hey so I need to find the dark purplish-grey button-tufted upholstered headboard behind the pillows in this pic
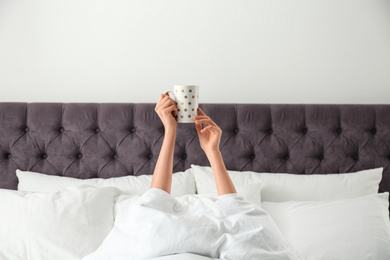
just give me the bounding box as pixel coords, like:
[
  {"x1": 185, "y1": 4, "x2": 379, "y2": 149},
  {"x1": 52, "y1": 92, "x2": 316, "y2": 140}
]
[{"x1": 0, "y1": 103, "x2": 390, "y2": 199}]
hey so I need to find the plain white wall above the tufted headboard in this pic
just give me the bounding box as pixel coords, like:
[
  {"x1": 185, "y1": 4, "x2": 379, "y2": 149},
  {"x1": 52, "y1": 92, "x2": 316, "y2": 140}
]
[{"x1": 0, "y1": 0, "x2": 390, "y2": 104}]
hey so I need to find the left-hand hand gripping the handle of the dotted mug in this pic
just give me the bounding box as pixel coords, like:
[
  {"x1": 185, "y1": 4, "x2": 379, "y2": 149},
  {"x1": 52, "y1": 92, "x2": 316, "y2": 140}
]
[{"x1": 154, "y1": 94, "x2": 178, "y2": 130}]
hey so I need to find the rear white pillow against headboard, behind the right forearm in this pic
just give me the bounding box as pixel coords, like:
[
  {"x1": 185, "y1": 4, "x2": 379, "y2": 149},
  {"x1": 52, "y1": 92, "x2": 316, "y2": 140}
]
[{"x1": 191, "y1": 164, "x2": 383, "y2": 202}]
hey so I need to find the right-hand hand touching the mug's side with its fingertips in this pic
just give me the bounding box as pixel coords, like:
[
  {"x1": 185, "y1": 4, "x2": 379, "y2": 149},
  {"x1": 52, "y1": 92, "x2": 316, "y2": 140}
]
[{"x1": 194, "y1": 108, "x2": 222, "y2": 154}]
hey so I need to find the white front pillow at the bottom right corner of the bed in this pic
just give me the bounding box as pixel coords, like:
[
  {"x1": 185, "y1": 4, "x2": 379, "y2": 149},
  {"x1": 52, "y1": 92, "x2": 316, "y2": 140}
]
[{"x1": 262, "y1": 192, "x2": 390, "y2": 260}]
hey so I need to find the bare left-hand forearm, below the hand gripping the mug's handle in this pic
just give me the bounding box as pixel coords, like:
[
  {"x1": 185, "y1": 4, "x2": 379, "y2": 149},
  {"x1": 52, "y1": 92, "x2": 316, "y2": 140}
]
[{"x1": 150, "y1": 129, "x2": 176, "y2": 193}]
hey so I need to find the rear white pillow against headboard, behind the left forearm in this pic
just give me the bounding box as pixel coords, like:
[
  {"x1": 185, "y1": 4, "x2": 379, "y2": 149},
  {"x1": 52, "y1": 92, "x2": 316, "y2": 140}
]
[{"x1": 16, "y1": 170, "x2": 195, "y2": 196}]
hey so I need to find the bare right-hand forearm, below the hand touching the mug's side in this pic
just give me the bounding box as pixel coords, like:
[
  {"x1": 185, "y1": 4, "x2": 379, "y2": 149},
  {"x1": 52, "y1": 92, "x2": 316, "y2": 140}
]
[{"x1": 206, "y1": 150, "x2": 237, "y2": 195}]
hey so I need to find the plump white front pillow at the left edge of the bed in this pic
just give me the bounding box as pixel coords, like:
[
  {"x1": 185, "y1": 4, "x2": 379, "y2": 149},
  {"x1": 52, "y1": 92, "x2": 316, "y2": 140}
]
[{"x1": 0, "y1": 185, "x2": 118, "y2": 260}]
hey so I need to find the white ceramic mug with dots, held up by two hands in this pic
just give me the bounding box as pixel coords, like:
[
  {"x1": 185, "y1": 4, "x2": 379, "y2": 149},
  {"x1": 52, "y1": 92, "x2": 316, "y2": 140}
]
[{"x1": 164, "y1": 85, "x2": 199, "y2": 123}]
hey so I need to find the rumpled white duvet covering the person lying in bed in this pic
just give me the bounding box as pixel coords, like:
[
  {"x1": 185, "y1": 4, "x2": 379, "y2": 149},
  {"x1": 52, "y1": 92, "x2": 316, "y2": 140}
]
[{"x1": 83, "y1": 189, "x2": 301, "y2": 260}]
